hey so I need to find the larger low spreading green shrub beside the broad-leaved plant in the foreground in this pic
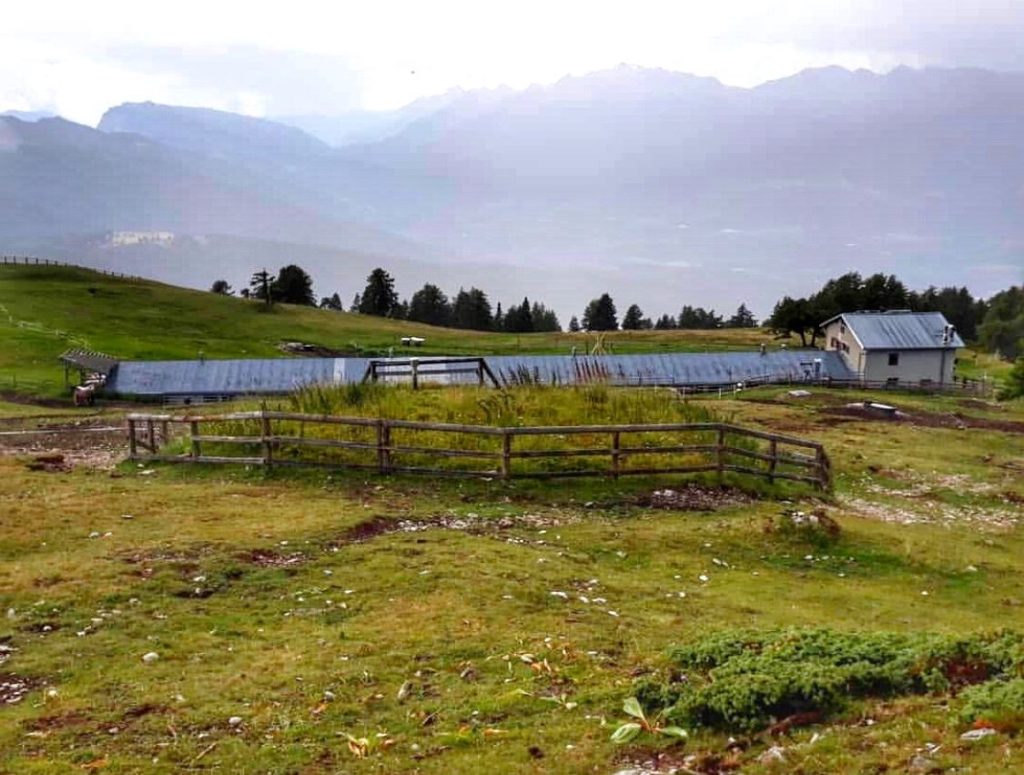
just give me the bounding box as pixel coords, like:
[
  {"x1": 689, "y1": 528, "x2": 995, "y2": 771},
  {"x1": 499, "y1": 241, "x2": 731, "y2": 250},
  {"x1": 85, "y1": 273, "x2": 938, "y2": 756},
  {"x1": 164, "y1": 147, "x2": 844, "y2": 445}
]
[{"x1": 637, "y1": 629, "x2": 1024, "y2": 731}]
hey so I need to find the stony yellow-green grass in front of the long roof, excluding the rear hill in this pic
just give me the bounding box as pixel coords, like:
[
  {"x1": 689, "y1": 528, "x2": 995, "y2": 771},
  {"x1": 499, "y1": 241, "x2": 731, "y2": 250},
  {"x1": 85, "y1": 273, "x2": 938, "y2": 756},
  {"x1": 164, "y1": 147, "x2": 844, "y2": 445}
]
[{"x1": 0, "y1": 388, "x2": 1024, "y2": 773}]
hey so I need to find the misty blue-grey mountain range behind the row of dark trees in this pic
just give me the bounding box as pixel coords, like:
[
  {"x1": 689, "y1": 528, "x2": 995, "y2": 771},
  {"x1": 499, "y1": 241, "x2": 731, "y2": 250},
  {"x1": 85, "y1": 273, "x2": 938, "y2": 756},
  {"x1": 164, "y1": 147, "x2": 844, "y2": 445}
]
[{"x1": 0, "y1": 66, "x2": 1024, "y2": 322}]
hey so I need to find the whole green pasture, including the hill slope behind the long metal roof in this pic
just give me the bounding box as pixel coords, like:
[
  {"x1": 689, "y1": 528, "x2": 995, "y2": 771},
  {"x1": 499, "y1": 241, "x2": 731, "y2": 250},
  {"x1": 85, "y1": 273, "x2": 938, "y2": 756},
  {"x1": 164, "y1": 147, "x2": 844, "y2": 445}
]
[{"x1": 0, "y1": 266, "x2": 1024, "y2": 775}]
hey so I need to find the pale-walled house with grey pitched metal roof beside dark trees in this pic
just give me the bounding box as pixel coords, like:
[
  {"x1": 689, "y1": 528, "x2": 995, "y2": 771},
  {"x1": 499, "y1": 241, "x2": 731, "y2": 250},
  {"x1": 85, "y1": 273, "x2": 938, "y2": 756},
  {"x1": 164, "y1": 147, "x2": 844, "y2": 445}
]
[{"x1": 821, "y1": 310, "x2": 964, "y2": 385}]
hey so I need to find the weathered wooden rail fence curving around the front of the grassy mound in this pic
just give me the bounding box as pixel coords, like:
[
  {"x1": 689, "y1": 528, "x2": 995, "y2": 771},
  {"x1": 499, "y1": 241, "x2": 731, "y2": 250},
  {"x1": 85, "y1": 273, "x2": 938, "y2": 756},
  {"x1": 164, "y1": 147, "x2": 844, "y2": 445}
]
[{"x1": 127, "y1": 411, "x2": 831, "y2": 490}]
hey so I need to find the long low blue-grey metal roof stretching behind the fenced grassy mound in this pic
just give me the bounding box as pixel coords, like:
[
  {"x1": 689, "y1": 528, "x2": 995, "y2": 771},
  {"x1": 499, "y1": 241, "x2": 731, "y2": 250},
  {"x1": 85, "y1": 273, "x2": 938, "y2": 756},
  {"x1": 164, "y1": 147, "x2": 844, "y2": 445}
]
[{"x1": 108, "y1": 350, "x2": 856, "y2": 397}]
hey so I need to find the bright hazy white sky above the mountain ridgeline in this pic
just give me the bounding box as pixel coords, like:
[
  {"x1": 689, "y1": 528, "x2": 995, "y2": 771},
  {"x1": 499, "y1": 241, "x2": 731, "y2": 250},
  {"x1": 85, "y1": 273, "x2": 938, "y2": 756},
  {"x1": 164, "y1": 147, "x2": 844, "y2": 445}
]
[{"x1": 0, "y1": 0, "x2": 1024, "y2": 124}]
